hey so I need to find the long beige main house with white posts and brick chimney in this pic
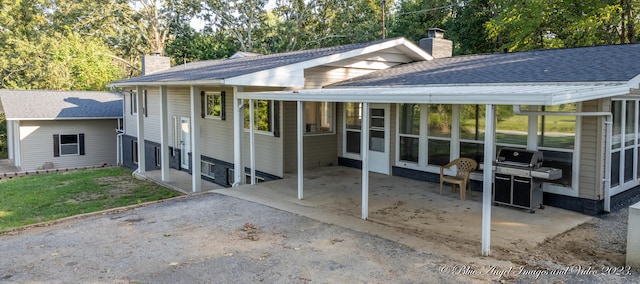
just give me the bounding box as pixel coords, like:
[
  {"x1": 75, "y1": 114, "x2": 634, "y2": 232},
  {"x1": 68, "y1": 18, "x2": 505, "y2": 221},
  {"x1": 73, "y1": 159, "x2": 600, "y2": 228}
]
[{"x1": 111, "y1": 30, "x2": 640, "y2": 254}]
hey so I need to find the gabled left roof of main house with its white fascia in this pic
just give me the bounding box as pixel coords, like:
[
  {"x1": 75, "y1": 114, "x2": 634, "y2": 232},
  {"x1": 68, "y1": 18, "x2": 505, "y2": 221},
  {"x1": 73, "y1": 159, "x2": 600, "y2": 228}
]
[{"x1": 110, "y1": 38, "x2": 431, "y2": 87}]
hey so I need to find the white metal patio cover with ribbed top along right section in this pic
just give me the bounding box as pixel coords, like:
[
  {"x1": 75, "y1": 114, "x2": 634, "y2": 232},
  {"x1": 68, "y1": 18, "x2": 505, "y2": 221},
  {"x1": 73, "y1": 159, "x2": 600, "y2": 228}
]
[{"x1": 238, "y1": 82, "x2": 629, "y2": 105}]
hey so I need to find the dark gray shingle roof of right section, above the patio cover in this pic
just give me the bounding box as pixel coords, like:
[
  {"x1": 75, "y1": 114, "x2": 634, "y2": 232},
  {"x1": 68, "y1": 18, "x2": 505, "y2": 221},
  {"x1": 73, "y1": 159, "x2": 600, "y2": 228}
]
[{"x1": 331, "y1": 44, "x2": 640, "y2": 87}]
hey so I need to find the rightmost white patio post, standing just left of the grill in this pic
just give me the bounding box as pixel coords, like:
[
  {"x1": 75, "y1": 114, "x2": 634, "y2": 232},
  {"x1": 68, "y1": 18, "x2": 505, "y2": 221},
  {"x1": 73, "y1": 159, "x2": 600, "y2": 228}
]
[{"x1": 482, "y1": 105, "x2": 496, "y2": 256}]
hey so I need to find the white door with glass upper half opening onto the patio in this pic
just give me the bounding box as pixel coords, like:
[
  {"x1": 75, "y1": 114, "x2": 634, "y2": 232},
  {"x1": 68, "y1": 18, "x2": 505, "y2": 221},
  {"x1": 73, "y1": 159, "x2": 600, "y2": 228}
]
[{"x1": 369, "y1": 104, "x2": 390, "y2": 175}]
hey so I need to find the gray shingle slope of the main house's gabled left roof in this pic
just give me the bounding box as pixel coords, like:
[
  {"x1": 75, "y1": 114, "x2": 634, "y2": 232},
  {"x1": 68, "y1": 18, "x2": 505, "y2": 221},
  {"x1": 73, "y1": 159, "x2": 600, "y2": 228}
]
[{"x1": 113, "y1": 38, "x2": 397, "y2": 85}]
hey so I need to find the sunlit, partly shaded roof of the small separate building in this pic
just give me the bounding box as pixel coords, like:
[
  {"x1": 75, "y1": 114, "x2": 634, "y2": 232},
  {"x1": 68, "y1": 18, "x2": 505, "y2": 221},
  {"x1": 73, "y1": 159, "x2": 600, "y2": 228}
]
[{"x1": 0, "y1": 90, "x2": 122, "y2": 120}]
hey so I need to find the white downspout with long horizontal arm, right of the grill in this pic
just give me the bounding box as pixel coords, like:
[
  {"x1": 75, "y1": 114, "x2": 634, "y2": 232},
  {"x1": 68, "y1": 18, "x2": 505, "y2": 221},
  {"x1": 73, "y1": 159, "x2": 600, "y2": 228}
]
[{"x1": 513, "y1": 105, "x2": 613, "y2": 212}]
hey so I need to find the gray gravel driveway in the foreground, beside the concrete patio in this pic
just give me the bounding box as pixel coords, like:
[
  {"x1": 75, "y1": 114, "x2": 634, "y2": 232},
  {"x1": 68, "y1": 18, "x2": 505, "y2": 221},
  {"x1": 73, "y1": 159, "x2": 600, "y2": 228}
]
[{"x1": 0, "y1": 193, "x2": 640, "y2": 283}]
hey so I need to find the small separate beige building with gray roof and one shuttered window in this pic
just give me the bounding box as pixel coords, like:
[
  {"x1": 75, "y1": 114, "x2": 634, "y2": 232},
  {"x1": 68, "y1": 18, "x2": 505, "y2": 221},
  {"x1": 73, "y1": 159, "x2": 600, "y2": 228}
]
[{"x1": 0, "y1": 90, "x2": 122, "y2": 171}]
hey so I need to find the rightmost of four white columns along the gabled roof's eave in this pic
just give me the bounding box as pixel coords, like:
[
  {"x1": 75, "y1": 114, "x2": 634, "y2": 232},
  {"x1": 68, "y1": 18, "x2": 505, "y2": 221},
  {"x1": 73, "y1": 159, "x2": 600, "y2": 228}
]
[{"x1": 233, "y1": 87, "x2": 244, "y2": 186}]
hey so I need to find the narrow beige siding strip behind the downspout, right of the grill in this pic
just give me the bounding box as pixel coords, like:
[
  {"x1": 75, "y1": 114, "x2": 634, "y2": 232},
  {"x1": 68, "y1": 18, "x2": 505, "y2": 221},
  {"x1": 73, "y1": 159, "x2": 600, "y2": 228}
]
[{"x1": 576, "y1": 100, "x2": 610, "y2": 200}]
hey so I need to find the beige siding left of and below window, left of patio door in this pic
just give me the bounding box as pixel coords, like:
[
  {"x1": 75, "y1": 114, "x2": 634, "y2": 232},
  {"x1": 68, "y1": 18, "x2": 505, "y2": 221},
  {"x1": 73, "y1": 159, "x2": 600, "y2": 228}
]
[{"x1": 283, "y1": 102, "x2": 338, "y2": 173}]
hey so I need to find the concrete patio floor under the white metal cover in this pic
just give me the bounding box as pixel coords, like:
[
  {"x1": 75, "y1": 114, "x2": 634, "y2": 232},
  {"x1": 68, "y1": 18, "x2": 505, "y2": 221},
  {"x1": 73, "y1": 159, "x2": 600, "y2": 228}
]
[{"x1": 136, "y1": 166, "x2": 592, "y2": 262}]
